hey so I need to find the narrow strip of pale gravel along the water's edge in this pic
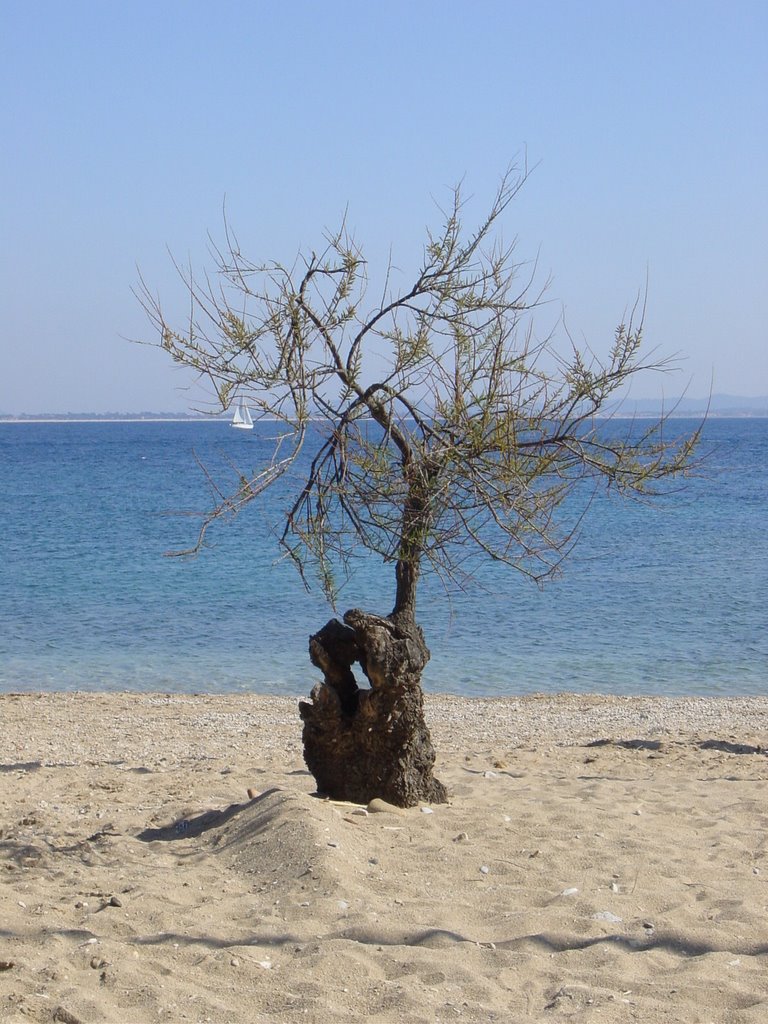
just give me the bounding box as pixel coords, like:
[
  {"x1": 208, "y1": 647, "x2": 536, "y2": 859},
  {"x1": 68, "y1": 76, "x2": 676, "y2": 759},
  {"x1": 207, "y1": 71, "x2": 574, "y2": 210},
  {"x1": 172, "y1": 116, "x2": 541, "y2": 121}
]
[{"x1": 0, "y1": 692, "x2": 768, "y2": 769}]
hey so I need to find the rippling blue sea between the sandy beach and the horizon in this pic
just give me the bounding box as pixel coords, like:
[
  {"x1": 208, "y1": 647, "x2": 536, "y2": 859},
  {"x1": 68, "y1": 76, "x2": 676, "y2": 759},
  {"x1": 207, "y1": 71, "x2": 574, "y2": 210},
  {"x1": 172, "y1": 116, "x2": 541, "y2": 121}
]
[{"x1": 0, "y1": 418, "x2": 768, "y2": 697}]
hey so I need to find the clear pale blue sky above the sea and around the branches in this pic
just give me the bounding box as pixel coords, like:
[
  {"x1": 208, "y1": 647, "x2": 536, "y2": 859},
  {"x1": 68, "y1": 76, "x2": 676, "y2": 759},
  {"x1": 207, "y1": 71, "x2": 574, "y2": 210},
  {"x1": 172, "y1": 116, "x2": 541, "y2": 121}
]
[{"x1": 0, "y1": 0, "x2": 768, "y2": 413}]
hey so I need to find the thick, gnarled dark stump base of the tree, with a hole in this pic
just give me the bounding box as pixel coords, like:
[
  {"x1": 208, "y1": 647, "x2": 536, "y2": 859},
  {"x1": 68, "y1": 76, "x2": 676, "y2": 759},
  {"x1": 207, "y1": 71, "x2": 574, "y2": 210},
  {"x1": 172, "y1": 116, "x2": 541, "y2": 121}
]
[{"x1": 299, "y1": 609, "x2": 446, "y2": 807}]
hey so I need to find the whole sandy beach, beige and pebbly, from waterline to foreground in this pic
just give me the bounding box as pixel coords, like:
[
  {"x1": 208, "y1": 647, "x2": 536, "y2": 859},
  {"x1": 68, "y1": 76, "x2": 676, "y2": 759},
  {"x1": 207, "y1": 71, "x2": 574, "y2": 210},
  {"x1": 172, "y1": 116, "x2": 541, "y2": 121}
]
[{"x1": 0, "y1": 694, "x2": 768, "y2": 1024}]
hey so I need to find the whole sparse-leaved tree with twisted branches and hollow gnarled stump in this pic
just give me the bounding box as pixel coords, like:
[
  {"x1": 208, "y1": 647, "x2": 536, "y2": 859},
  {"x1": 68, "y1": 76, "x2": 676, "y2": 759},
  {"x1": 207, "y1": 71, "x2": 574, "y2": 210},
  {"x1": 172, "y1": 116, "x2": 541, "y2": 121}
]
[{"x1": 140, "y1": 170, "x2": 698, "y2": 806}]
